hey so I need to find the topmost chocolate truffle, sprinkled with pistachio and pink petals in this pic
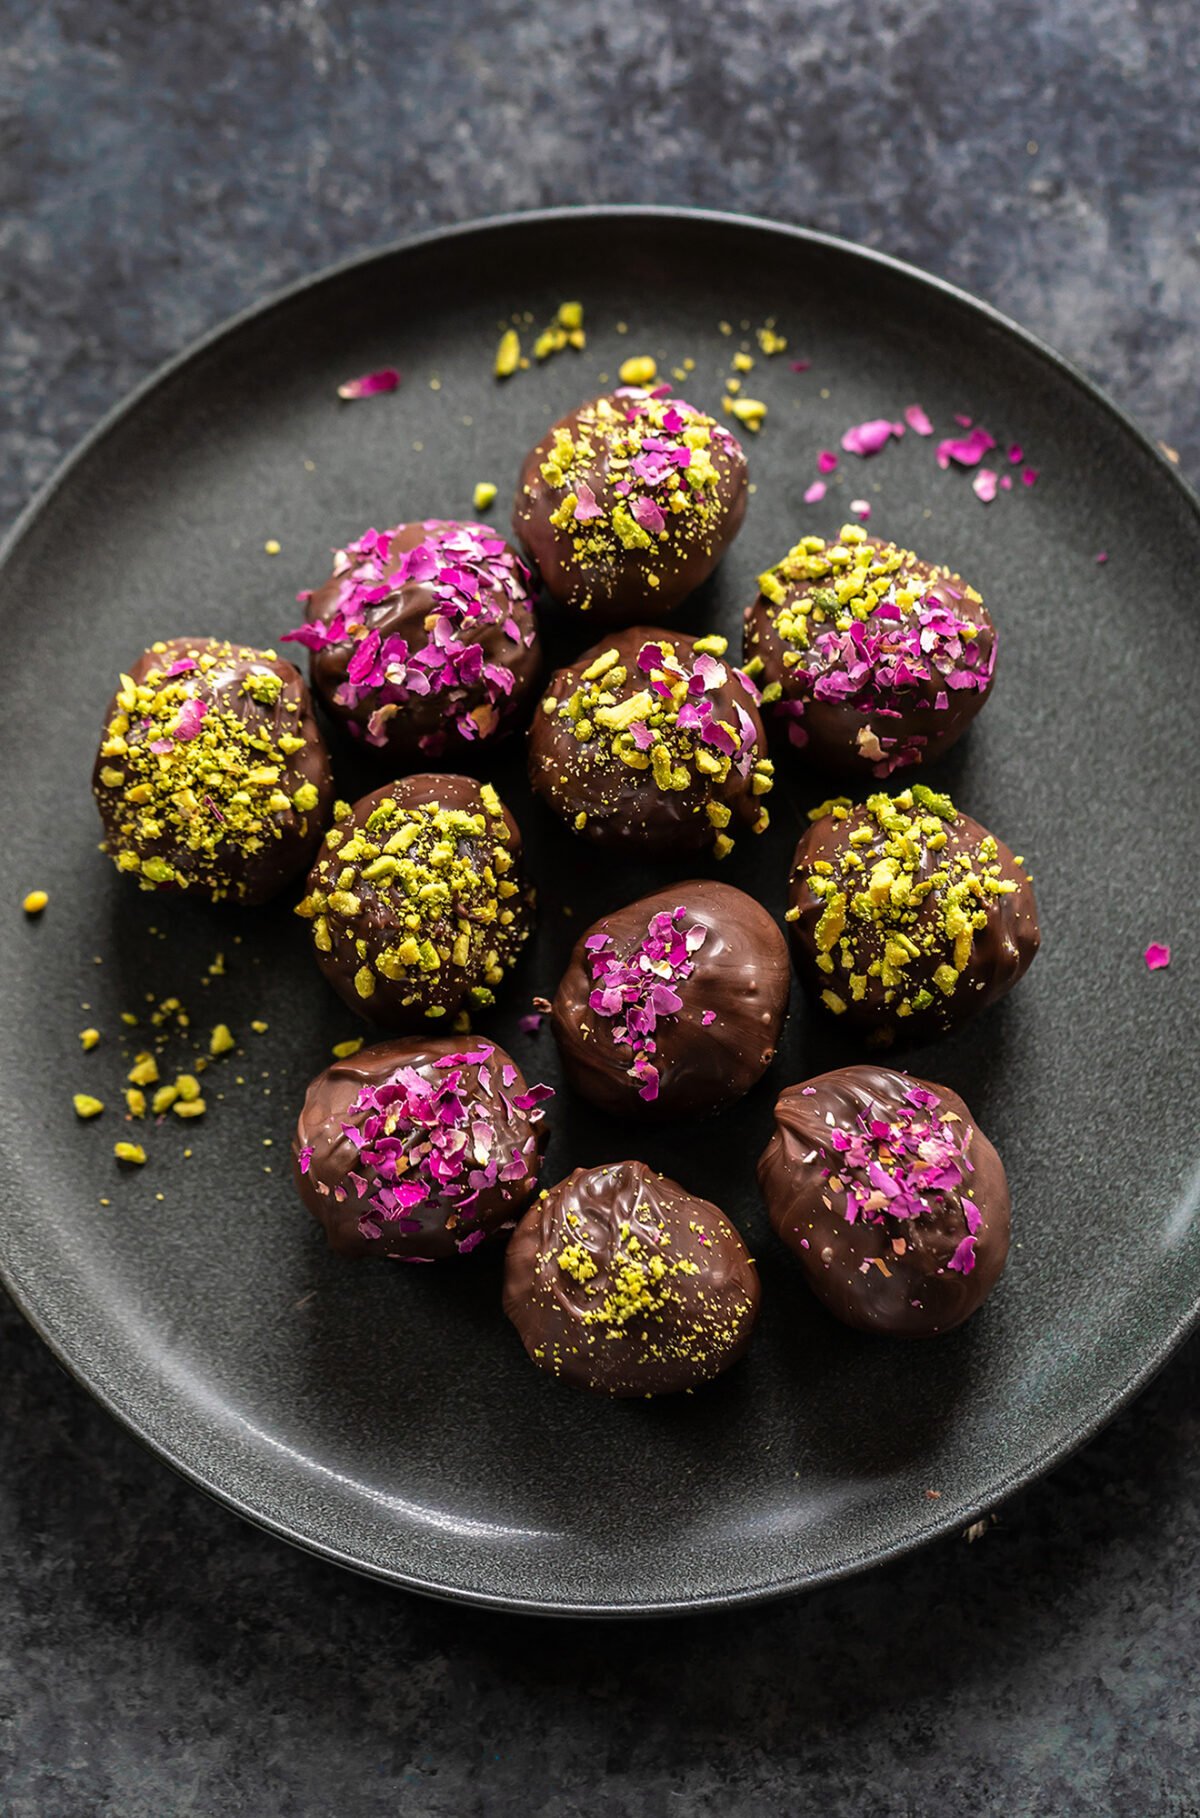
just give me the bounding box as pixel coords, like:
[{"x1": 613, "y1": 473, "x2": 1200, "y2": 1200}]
[{"x1": 513, "y1": 385, "x2": 747, "y2": 625}]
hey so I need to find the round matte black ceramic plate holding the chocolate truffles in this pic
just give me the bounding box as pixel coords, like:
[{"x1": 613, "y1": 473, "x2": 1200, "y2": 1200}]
[{"x1": 0, "y1": 211, "x2": 1200, "y2": 1613}]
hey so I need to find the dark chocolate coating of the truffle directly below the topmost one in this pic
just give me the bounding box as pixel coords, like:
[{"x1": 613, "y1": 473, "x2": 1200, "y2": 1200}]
[{"x1": 529, "y1": 625, "x2": 771, "y2": 858}]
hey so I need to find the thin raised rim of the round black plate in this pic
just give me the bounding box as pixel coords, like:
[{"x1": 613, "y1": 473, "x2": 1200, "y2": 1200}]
[{"x1": 0, "y1": 202, "x2": 1200, "y2": 1620}]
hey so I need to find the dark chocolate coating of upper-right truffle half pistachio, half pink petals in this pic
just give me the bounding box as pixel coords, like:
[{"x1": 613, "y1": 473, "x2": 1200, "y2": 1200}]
[{"x1": 745, "y1": 527, "x2": 996, "y2": 776}]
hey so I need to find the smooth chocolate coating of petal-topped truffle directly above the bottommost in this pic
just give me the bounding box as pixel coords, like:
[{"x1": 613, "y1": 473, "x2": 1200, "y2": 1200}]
[{"x1": 551, "y1": 878, "x2": 791, "y2": 1122}]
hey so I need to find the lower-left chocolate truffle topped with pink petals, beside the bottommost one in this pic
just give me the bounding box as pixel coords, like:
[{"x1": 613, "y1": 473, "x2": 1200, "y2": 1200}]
[{"x1": 291, "y1": 1036, "x2": 553, "y2": 1262}]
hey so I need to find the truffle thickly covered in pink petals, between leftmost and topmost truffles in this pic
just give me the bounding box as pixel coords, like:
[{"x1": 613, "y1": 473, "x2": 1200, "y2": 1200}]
[{"x1": 285, "y1": 518, "x2": 538, "y2": 765}]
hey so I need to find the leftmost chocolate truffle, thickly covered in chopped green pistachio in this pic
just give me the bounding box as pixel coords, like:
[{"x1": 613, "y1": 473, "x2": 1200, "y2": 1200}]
[{"x1": 91, "y1": 638, "x2": 333, "y2": 904}]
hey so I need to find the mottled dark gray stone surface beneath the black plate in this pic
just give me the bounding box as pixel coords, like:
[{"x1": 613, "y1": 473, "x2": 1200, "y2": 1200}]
[{"x1": 0, "y1": 0, "x2": 1200, "y2": 1818}]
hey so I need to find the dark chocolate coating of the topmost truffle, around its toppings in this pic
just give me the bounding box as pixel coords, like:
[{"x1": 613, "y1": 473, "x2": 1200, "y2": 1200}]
[{"x1": 513, "y1": 387, "x2": 747, "y2": 625}]
